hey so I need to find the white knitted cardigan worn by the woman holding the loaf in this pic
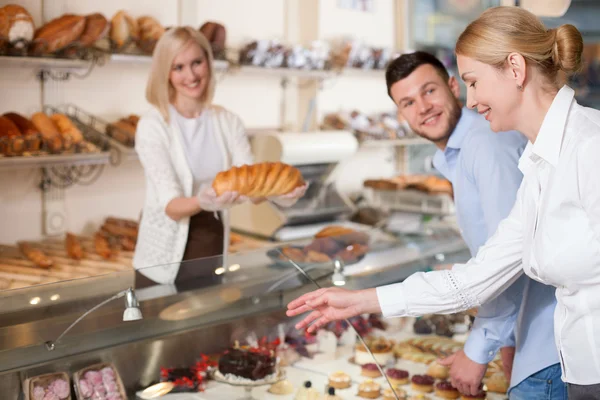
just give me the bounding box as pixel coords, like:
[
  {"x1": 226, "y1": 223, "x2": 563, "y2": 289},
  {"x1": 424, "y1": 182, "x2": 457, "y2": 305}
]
[{"x1": 133, "y1": 105, "x2": 252, "y2": 284}]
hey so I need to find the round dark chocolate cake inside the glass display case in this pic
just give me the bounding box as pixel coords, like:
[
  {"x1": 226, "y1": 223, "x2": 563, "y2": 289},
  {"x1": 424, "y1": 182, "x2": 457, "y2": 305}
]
[{"x1": 219, "y1": 348, "x2": 276, "y2": 381}]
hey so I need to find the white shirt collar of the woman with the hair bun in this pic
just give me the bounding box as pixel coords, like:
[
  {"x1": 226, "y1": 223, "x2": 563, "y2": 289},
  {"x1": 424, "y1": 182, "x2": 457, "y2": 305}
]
[{"x1": 523, "y1": 85, "x2": 575, "y2": 167}]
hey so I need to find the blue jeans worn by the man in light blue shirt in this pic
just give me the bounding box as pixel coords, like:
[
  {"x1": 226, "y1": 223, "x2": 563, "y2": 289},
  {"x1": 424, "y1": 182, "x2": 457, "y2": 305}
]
[{"x1": 508, "y1": 364, "x2": 567, "y2": 400}]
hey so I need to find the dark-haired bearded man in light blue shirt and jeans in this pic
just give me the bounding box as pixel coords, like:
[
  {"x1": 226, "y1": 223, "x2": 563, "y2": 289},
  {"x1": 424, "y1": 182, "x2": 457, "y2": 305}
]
[{"x1": 386, "y1": 52, "x2": 567, "y2": 400}]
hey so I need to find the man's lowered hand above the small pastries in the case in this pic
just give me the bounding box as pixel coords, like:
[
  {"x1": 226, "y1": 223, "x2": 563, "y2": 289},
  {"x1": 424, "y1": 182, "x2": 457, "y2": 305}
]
[{"x1": 438, "y1": 350, "x2": 487, "y2": 396}]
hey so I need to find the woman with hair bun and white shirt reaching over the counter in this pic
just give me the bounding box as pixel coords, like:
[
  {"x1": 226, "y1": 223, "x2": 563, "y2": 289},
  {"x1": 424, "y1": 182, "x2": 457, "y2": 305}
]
[{"x1": 288, "y1": 7, "x2": 600, "y2": 400}]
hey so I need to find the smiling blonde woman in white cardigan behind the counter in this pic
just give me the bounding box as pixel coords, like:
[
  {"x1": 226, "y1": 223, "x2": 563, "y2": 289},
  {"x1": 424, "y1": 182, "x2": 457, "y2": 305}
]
[{"x1": 133, "y1": 27, "x2": 306, "y2": 288}]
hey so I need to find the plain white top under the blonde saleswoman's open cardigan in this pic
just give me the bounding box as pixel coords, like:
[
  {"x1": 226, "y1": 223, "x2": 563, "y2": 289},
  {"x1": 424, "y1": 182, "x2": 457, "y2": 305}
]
[{"x1": 170, "y1": 106, "x2": 223, "y2": 193}]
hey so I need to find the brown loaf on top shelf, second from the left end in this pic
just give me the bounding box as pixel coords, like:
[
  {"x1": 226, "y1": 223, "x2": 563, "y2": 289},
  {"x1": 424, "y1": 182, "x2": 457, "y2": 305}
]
[{"x1": 33, "y1": 14, "x2": 85, "y2": 53}]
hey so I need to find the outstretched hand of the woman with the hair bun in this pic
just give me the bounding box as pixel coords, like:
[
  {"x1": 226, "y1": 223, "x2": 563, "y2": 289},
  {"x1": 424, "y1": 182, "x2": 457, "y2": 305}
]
[{"x1": 287, "y1": 288, "x2": 381, "y2": 332}]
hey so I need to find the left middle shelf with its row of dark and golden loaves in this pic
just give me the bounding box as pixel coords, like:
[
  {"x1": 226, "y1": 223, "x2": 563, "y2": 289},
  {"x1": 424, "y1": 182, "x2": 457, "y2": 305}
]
[{"x1": 0, "y1": 106, "x2": 110, "y2": 170}]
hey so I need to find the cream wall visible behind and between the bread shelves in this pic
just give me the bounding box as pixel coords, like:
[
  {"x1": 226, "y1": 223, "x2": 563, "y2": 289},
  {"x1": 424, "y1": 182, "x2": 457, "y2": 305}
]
[{"x1": 0, "y1": 0, "x2": 420, "y2": 243}]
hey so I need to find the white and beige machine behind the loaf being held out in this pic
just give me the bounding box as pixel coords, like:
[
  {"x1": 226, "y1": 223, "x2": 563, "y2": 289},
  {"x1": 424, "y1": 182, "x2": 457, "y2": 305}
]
[{"x1": 231, "y1": 131, "x2": 358, "y2": 241}]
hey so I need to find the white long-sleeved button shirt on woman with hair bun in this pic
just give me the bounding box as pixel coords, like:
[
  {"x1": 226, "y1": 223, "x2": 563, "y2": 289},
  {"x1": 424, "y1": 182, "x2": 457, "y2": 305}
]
[{"x1": 377, "y1": 86, "x2": 600, "y2": 385}]
